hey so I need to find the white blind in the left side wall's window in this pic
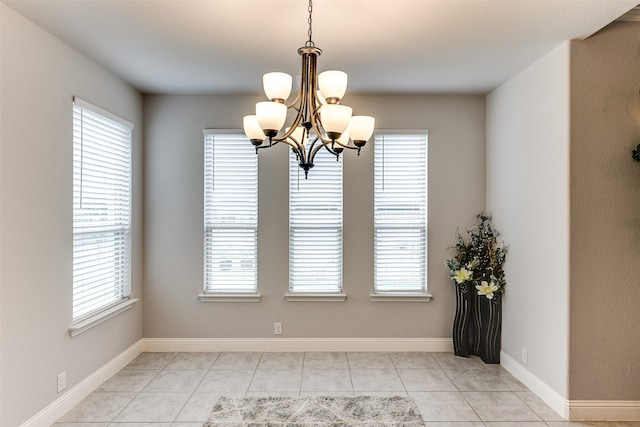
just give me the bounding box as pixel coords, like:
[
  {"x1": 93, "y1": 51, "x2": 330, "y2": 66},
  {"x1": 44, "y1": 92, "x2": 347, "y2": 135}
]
[{"x1": 73, "y1": 98, "x2": 133, "y2": 322}]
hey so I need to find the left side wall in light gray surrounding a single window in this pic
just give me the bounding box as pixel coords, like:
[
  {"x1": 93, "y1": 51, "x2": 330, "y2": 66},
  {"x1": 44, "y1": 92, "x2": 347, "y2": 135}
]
[{"x1": 0, "y1": 4, "x2": 142, "y2": 426}]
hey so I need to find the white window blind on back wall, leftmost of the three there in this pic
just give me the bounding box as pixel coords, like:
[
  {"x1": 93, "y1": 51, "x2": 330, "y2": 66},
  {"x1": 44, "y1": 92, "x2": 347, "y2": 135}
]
[{"x1": 204, "y1": 130, "x2": 258, "y2": 293}]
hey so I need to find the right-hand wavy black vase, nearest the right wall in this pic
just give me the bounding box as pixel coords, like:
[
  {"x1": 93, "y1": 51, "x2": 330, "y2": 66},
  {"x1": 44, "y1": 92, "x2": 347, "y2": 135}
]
[{"x1": 472, "y1": 294, "x2": 502, "y2": 363}]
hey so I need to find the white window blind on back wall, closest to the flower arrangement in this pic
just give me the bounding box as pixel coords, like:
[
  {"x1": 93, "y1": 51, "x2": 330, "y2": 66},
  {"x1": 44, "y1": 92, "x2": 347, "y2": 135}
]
[{"x1": 374, "y1": 134, "x2": 427, "y2": 293}]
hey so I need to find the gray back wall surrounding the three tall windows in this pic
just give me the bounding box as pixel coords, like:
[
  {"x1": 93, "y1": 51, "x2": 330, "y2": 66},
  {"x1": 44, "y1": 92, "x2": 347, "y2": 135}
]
[{"x1": 144, "y1": 94, "x2": 485, "y2": 338}]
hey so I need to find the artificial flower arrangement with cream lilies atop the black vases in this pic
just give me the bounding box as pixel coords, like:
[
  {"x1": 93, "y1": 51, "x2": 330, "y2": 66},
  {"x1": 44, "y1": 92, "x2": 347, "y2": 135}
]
[{"x1": 445, "y1": 213, "x2": 507, "y2": 299}]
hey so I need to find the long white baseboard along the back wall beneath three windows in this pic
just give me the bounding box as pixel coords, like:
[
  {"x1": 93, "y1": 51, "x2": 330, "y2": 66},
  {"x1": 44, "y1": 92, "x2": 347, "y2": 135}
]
[{"x1": 142, "y1": 338, "x2": 453, "y2": 352}]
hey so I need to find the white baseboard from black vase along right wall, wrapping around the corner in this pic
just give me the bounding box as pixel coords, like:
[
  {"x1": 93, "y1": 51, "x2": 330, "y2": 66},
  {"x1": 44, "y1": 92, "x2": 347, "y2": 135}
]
[{"x1": 500, "y1": 352, "x2": 640, "y2": 421}]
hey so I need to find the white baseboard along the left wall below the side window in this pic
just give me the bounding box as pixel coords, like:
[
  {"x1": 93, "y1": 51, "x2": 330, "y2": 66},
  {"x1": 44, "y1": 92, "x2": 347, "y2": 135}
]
[{"x1": 20, "y1": 340, "x2": 142, "y2": 427}]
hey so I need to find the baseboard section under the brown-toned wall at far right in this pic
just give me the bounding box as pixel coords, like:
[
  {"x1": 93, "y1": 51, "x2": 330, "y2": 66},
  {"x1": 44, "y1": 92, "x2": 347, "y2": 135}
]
[{"x1": 569, "y1": 400, "x2": 640, "y2": 421}]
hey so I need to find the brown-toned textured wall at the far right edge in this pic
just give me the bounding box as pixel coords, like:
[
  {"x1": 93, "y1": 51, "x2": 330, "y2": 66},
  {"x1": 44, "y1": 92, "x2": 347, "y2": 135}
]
[{"x1": 569, "y1": 22, "x2": 640, "y2": 401}]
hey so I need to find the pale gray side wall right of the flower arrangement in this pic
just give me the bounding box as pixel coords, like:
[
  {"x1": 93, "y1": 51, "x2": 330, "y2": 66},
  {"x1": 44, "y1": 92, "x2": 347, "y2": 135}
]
[{"x1": 487, "y1": 43, "x2": 569, "y2": 398}]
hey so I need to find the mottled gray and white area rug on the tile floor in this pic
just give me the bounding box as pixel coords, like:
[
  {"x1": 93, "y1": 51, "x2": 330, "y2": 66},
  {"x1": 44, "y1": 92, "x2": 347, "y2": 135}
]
[{"x1": 204, "y1": 396, "x2": 424, "y2": 427}]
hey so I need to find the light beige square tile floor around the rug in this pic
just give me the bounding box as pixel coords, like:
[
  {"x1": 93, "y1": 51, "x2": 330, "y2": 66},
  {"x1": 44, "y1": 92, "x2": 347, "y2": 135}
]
[{"x1": 54, "y1": 352, "x2": 640, "y2": 427}]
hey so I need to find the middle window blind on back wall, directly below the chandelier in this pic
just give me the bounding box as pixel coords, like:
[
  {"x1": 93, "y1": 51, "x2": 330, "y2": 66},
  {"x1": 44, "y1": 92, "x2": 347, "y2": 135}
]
[{"x1": 289, "y1": 149, "x2": 342, "y2": 293}]
